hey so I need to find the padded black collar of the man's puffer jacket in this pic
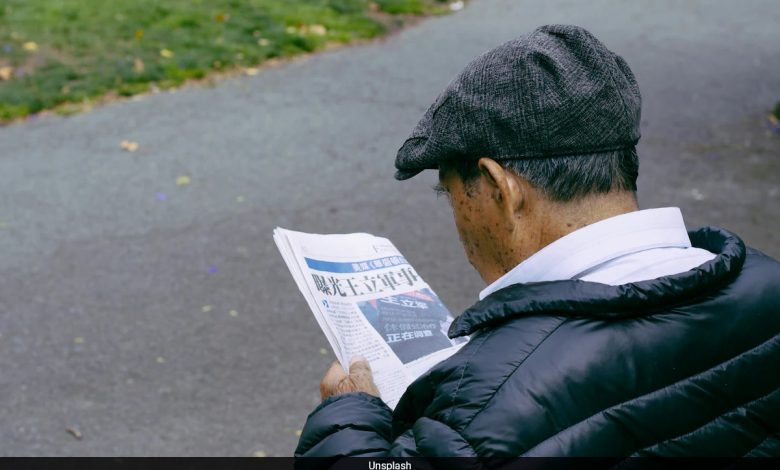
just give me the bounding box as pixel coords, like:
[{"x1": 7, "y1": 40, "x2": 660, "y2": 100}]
[{"x1": 449, "y1": 227, "x2": 745, "y2": 338}]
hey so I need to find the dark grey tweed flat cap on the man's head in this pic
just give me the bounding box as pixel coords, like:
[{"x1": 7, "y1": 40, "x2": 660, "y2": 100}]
[{"x1": 395, "y1": 25, "x2": 641, "y2": 180}]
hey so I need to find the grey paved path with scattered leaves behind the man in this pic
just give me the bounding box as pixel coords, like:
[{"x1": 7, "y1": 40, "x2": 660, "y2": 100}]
[{"x1": 0, "y1": 0, "x2": 780, "y2": 455}]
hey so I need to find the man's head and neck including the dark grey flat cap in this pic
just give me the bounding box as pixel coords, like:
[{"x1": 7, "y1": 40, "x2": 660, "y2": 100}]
[{"x1": 396, "y1": 25, "x2": 641, "y2": 282}]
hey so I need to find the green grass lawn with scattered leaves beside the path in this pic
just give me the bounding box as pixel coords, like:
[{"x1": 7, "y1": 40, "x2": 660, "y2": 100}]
[{"x1": 0, "y1": 0, "x2": 448, "y2": 123}]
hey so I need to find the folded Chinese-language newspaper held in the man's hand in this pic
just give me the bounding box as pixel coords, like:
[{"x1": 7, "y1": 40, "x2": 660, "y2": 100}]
[{"x1": 274, "y1": 227, "x2": 468, "y2": 408}]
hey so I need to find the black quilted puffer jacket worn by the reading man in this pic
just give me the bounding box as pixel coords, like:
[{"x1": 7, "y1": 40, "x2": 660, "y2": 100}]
[{"x1": 296, "y1": 228, "x2": 780, "y2": 457}]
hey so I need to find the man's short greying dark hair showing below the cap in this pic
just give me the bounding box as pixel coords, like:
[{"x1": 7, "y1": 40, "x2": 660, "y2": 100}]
[{"x1": 448, "y1": 147, "x2": 639, "y2": 202}]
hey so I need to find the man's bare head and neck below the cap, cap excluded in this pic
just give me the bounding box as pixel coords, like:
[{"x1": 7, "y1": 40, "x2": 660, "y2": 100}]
[{"x1": 435, "y1": 149, "x2": 639, "y2": 283}]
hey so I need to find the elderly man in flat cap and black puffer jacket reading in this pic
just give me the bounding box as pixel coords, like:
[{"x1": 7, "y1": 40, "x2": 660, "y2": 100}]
[{"x1": 296, "y1": 26, "x2": 780, "y2": 457}]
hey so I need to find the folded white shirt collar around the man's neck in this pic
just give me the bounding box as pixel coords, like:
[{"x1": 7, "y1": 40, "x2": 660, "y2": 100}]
[{"x1": 479, "y1": 207, "x2": 691, "y2": 300}]
